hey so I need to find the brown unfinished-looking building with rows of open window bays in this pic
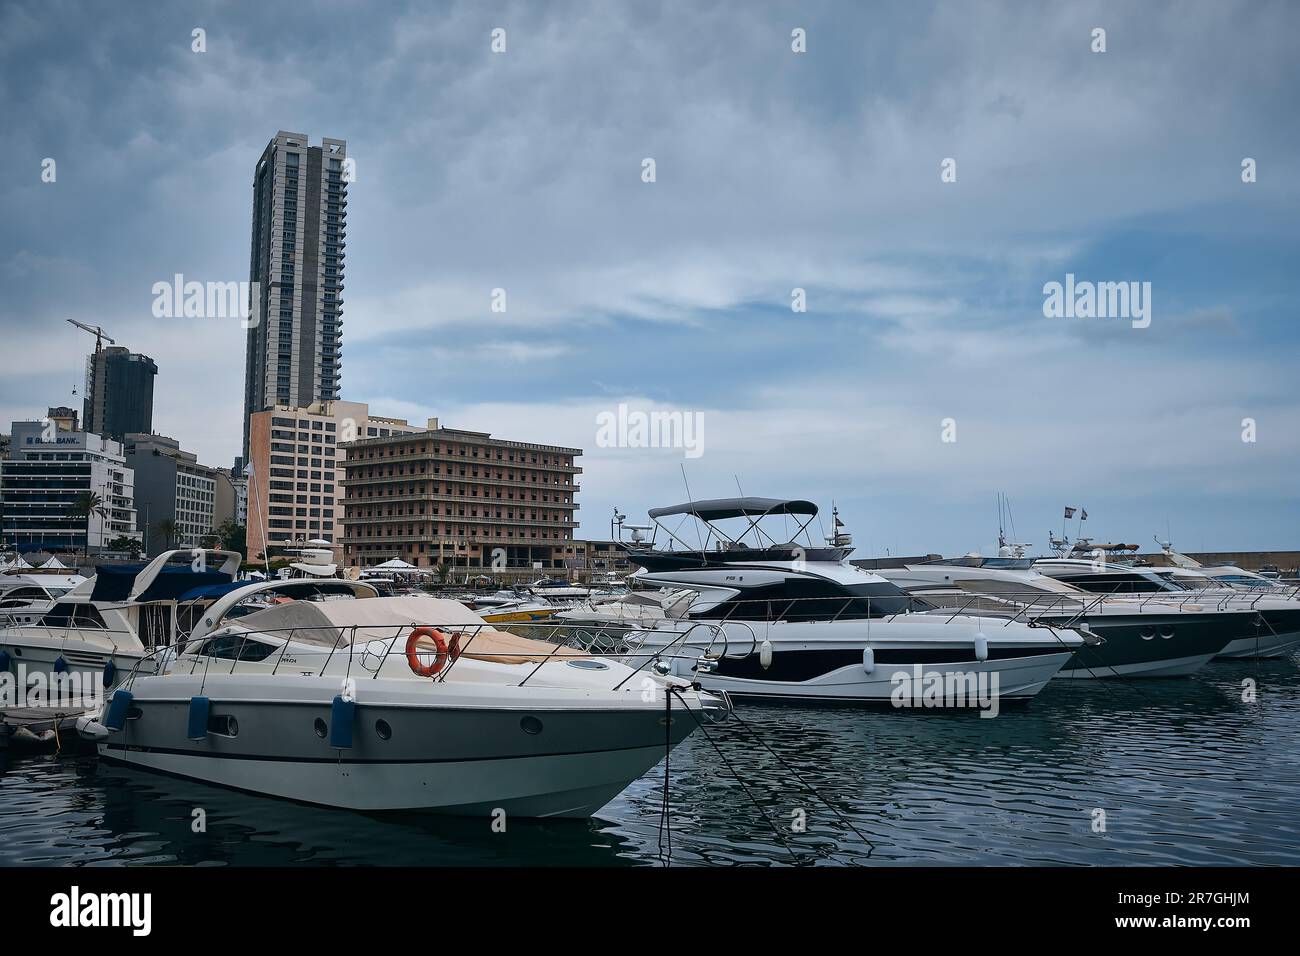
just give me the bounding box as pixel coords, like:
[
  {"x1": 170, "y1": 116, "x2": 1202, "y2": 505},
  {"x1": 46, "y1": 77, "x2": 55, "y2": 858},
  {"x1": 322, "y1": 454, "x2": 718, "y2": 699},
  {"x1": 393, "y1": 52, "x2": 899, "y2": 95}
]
[{"x1": 339, "y1": 419, "x2": 582, "y2": 571}]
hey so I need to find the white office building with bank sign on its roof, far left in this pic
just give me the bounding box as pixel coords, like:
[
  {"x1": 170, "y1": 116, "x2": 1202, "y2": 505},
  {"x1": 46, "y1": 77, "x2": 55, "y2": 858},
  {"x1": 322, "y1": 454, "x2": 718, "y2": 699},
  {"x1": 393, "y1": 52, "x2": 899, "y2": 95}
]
[{"x1": 0, "y1": 408, "x2": 140, "y2": 551}]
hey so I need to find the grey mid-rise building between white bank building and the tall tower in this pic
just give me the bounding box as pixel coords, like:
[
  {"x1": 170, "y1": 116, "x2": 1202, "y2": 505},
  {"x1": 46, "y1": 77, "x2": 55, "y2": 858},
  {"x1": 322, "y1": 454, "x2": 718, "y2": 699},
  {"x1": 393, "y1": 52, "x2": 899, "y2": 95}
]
[{"x1": 125, "y1": 434, "x2": 220, "y2": 554}]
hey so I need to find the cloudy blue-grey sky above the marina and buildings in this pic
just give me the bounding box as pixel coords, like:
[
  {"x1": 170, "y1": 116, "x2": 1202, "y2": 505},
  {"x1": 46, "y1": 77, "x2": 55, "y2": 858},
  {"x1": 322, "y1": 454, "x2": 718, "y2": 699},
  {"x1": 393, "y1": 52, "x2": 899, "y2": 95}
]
[{"x1": 0, "y1": 0, "x2": 1300, "y2": 555}]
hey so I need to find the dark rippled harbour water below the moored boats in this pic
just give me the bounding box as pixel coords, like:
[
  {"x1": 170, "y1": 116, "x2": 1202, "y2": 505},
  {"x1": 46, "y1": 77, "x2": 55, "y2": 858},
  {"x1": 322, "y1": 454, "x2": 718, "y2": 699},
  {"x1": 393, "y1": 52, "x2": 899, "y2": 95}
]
[{"x1": 0, "y1": 658, "x2": 1300, "y2": 866}]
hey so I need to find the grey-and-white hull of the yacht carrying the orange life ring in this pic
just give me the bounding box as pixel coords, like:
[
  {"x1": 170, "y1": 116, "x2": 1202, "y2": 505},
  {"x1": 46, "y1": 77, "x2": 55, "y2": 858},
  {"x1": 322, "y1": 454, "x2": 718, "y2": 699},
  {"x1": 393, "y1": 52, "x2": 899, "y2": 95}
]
[{"x1": 99, "y1": 674, "x2": 699, "y2": 818}]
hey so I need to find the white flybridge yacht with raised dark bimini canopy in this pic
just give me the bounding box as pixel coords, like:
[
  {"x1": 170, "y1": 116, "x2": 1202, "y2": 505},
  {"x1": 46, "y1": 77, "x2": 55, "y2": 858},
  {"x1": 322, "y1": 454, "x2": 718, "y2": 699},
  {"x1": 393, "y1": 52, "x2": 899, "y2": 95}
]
[{"x1": 608, "y1": 497, "x2": 1084, "y2": 706}]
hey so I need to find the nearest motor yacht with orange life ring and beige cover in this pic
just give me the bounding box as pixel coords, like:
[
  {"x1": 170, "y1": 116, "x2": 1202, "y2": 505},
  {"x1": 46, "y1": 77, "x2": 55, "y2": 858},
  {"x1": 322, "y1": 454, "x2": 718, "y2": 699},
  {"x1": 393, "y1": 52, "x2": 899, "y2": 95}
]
[{"x1": 96, "y1": 584, "x2": 729, "y2": 817}]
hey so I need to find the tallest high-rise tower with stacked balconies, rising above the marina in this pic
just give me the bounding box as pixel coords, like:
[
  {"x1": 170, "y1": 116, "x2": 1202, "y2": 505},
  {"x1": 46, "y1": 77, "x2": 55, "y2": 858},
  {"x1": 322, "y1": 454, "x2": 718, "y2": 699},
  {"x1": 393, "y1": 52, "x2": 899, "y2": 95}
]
[{"x1": 244, "y1": 130, "x2": 351, "y2": 460}]
